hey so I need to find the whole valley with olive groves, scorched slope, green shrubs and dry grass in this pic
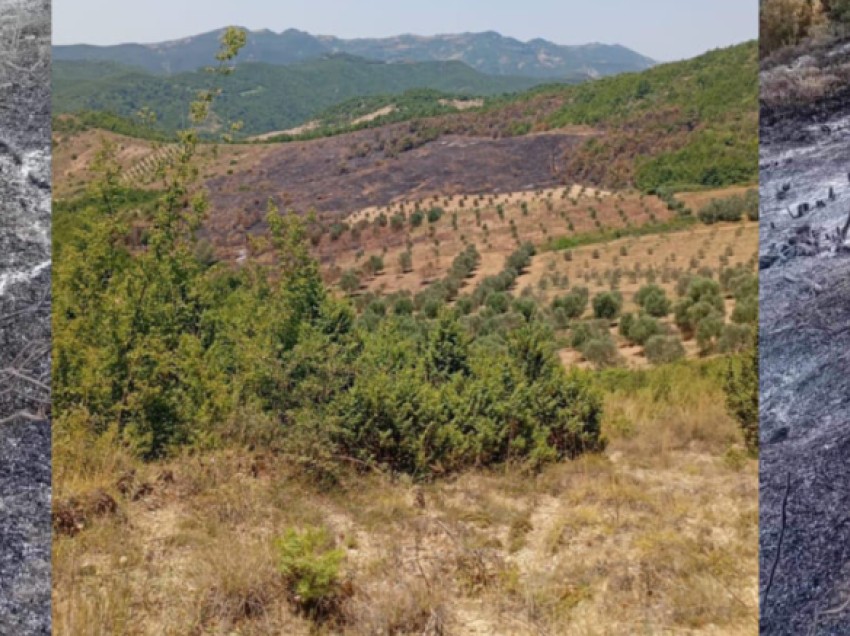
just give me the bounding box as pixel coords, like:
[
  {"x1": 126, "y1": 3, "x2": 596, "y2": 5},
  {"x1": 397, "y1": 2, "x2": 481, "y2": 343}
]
[{"x1": 52, "y1": 26, "x2": 759, "y2": 636}]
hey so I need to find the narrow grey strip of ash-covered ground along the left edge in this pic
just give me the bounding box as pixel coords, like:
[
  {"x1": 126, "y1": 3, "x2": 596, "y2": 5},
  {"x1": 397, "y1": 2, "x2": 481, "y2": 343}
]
[{"x1": 0, "y1": 0, "x2": 50, "y2": 636}]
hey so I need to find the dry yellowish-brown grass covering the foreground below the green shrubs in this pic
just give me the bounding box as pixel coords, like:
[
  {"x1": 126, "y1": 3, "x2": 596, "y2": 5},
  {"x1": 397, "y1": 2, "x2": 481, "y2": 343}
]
[{"x1": 53, "y1": 367, "x2": 758, "y2": 636}]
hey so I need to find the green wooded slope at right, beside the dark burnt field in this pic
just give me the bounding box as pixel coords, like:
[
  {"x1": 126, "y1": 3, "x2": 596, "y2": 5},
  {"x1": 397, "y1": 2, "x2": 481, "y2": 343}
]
[{"x1": 549, "y1": 42, "x2": 759, "y2": 191}]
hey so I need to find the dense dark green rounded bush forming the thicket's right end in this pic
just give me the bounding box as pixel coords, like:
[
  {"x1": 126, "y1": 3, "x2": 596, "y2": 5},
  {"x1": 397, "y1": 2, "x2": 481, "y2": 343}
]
[{"x1": 329, "y1": 320, "x2": 603, "y2": 474}]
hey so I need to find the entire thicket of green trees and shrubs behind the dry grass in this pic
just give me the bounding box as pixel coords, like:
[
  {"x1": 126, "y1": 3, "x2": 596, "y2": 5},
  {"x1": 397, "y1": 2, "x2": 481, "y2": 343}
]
[{"x1": 53, "y1": 36, "x2": 604, "y2": 474}]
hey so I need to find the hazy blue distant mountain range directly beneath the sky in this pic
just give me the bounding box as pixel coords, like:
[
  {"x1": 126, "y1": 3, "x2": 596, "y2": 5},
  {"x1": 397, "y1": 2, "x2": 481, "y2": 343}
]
[{"x1": 53, "y1": 29, "x2": 654, "y2": 79}]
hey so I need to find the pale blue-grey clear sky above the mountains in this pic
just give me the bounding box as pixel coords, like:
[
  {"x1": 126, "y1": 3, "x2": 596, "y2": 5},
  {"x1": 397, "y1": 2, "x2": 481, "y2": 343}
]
[{"x1": 53, "y1": 0, "x2": 758, "y2": 61}]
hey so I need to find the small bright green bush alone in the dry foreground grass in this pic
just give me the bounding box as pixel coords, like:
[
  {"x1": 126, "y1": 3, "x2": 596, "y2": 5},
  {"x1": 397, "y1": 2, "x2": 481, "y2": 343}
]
[{"x1": 276, "y1": 528, "x2": 345, "y2": 610}]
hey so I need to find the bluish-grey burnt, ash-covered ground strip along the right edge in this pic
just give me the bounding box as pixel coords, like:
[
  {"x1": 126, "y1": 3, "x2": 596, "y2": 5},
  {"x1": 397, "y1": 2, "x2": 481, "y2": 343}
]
[{"x1": 760, "y1": 36, "x2": 850, "y2": 636}]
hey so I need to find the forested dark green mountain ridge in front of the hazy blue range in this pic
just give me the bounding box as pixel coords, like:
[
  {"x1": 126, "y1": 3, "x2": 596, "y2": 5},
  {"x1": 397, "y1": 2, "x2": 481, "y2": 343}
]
[{"x1": 53, "y1": 54, "x2": 542, "y2": 135}]
